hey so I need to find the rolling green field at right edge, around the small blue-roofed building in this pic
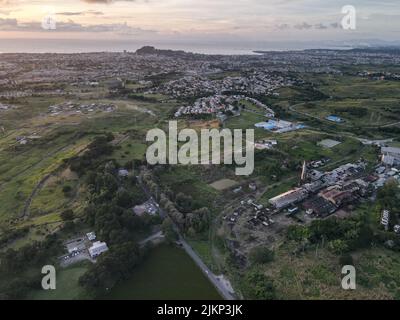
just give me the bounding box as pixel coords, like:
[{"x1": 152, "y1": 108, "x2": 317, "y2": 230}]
[{"x1": 290, "y1": 75, "x2": 400, "y2": 130}]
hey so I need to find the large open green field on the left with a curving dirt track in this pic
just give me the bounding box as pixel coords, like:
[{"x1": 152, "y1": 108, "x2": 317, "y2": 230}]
[{"x1": 0, "y1": 92, "x2": 175, "y2": 238}]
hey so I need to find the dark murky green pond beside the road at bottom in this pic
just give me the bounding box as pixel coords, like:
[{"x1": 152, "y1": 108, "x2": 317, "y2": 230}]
[{"x1": 105, "y1": 245, "x2": 221, "y2": 300}]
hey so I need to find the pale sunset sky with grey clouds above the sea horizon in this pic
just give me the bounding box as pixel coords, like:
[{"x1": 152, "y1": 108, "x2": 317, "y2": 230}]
[{"x1": 0, "y1": 0, "x2": 400, "y2": 49}]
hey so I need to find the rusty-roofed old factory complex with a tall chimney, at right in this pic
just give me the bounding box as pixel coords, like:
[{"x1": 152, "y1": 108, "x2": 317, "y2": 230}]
[{"x1": 269, "y1": 147, "x2": 400, "y2": 217}]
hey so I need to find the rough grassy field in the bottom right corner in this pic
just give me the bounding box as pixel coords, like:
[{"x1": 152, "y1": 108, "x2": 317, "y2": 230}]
[{"x1": 265, "y1": 242, "x2": 400, "y2": 299}]
